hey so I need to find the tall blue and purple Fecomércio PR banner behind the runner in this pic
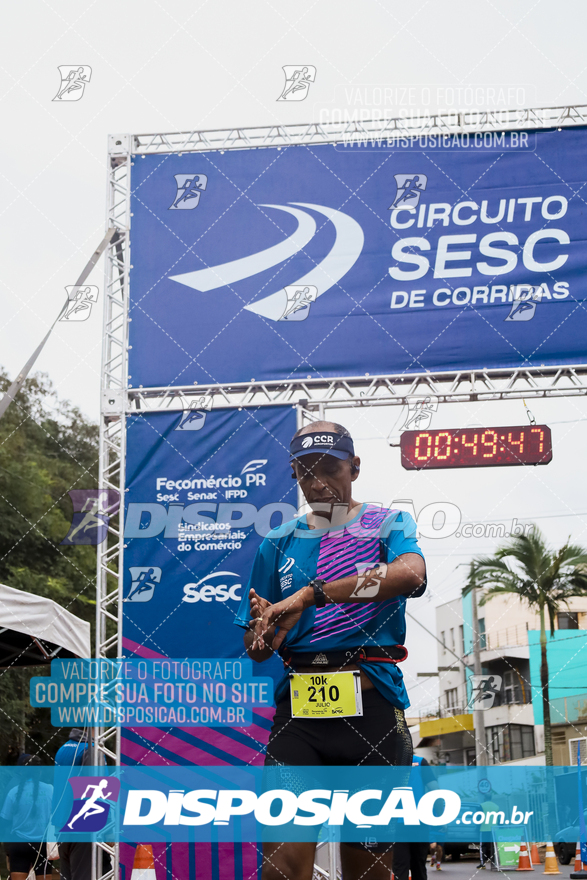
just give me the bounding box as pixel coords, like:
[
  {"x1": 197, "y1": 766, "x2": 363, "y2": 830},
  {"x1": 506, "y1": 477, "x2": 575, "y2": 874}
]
[{"x1": 121, "y1": 407, "x2": 297, "y2": 878}]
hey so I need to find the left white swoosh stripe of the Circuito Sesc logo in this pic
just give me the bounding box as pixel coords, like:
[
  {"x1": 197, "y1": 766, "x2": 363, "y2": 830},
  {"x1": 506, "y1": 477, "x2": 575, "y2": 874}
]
[{"x1": 170, "y1": 205, "x2": 316, "y2": 290}]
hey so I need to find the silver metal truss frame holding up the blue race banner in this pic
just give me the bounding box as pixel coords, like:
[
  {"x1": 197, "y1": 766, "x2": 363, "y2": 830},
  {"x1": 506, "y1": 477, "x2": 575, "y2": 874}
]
[{"x1": 99, "y1": 106, "x2": 587, "y2": 880}]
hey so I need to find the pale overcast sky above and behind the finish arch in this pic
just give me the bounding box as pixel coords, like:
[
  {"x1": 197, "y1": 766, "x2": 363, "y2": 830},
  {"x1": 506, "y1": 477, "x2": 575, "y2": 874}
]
[{"x1": 0, "y1": 0, "x2": 587, "y2": 706}]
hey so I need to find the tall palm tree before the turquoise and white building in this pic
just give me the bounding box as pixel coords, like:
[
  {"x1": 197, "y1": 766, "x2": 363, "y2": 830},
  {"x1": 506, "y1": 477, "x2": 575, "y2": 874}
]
[{"x1": 463, "y1": 528, "x2": 587, "y2": 767}]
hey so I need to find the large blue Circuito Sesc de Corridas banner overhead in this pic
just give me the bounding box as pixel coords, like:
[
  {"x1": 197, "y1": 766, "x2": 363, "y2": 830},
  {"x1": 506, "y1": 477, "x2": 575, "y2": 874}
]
[{"x1": 129, "y1": 128, "x2": 587, "y2": 388}]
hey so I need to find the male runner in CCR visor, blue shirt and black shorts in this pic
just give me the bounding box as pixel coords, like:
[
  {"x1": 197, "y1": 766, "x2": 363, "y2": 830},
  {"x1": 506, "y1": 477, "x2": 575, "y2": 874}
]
[{"x1": 236, "y1": 421, "x2": 426, "y2": 880}]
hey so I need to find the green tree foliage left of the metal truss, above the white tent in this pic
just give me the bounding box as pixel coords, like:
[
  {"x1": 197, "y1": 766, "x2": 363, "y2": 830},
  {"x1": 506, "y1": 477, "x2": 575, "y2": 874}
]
[{"x1": 0, "y1": 373, "x2": 98, "y2": 763}]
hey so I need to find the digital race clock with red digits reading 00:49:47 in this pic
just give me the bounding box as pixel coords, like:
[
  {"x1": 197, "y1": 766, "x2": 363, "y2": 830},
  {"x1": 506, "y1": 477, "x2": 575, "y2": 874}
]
[{"x1": 400, "y1": 425, "x2": 552, "y2": 471}]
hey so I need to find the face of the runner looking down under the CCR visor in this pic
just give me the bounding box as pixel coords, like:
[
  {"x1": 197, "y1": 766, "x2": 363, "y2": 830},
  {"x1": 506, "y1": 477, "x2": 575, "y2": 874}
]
[{"x1": 292, "y1": 453, "x2": 359, "y2": 504}]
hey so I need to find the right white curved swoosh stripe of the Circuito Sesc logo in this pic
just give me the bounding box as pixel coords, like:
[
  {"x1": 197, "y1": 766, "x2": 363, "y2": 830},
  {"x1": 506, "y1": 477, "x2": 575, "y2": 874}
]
[{"x1": 245, "y1": 202, "x2": 365, "y2": 321}]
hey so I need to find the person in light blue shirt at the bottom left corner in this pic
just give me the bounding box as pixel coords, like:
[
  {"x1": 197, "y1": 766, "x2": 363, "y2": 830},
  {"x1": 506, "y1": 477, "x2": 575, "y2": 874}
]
[{"x1": 0, "y1": 754, "x2": 53, "y2": 880}]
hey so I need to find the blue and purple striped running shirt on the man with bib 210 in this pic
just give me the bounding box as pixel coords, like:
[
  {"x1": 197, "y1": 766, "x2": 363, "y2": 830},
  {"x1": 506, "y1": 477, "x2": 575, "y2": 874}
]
[{"x1": 235, "y1": 504, "x2": 426, "y2": 709}]
